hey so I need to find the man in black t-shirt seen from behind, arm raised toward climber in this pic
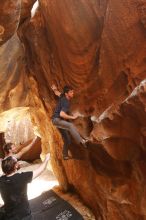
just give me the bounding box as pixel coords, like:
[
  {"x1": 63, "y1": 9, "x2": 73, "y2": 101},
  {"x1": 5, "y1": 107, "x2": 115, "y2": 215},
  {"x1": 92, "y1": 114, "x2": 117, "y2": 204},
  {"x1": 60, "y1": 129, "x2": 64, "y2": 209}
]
[{"x1": 0, "y1": 154, "x2": 50, "y2": 220}]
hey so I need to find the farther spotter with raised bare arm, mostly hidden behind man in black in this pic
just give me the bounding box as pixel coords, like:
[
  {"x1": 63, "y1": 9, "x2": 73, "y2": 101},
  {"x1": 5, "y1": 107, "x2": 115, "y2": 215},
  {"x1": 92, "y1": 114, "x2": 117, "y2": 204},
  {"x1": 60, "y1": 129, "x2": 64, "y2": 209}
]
[{"x1": 3, "y1": 136, "x2": 37, "y2": 160}]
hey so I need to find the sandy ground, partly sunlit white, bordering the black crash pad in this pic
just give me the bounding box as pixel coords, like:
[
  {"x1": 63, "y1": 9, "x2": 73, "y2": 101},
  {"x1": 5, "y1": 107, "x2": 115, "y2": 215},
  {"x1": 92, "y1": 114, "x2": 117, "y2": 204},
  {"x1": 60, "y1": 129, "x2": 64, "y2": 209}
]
[{"x1": 0, "y1": 160, "x2": 95, "y2": 220}]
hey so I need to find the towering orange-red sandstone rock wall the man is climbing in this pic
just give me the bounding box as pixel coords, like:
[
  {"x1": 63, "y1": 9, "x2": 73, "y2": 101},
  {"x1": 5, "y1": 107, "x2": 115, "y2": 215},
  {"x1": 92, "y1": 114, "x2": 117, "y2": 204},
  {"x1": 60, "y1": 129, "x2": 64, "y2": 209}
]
[{"x1": 0, "y1": 0, "x2": 146, "y2": 220}]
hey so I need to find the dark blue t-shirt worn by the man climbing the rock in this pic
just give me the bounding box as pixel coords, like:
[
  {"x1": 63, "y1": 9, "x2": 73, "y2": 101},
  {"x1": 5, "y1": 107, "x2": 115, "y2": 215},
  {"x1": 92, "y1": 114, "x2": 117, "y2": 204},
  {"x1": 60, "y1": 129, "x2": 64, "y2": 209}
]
[{"x1": 52, "y1": 96, "x2": 70, "y2": 119}]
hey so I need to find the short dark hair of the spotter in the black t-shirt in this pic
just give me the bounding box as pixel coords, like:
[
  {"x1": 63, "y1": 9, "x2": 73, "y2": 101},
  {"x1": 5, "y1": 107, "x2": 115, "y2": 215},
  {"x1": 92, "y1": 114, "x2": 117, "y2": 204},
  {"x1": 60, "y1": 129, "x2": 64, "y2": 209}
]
[{"x1": 1, "y1": 156, "x2": 17, "y2": 175}]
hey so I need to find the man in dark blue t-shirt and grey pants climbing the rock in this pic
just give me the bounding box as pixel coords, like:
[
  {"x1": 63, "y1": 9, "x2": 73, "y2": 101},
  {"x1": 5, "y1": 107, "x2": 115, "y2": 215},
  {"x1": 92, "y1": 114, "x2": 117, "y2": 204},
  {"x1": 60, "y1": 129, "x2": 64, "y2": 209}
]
[{"x1": 51, "y1": 85, "x2": 87, "y2": 160}]
